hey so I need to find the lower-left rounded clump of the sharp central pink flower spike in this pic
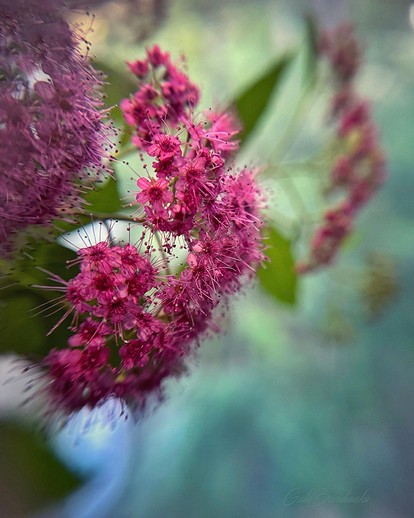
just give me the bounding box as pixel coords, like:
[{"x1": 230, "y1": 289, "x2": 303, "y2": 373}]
[{"x1": 44, "y1": 242, "x2": 180, "y2": 410}]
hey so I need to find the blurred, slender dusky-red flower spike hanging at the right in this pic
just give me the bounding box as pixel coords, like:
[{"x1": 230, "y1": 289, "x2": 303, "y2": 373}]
[{"x1": 298, "y1": 24, "x2": 386, "y2": 273}]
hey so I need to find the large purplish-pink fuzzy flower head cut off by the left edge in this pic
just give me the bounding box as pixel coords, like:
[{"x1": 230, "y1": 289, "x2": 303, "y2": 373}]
[{"x1": 0, "y1": 0, "x2": 105, "y2": 255}]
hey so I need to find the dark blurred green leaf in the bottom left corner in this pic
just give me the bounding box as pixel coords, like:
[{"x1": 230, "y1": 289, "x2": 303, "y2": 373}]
[{"x1": 0, "y1": 422, "x2": 80, "y2": 517}]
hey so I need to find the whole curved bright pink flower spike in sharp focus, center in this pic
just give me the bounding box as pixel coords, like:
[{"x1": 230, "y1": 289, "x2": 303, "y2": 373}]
[{"x1": 44, "y1": 46, "x2": 263, "y2": 416}]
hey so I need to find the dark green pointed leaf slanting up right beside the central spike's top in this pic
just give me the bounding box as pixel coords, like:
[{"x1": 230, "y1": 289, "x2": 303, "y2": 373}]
[{"x1": 233, "y1": 54, "x2": 294, "y2": 142}]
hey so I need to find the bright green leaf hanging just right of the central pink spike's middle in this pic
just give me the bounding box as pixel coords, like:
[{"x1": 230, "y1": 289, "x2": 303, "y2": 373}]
[{"x1": 258, "y1": 227, "x2": 297, "y2": 305}]
